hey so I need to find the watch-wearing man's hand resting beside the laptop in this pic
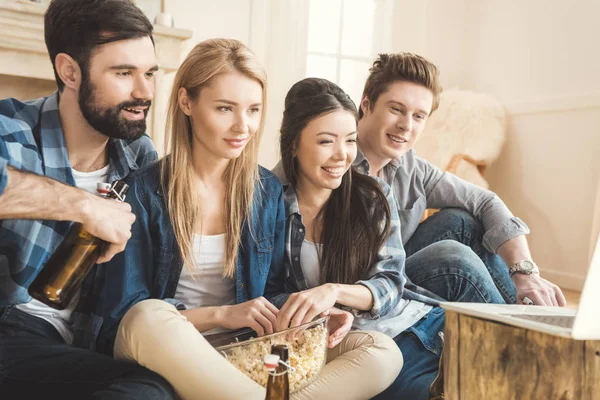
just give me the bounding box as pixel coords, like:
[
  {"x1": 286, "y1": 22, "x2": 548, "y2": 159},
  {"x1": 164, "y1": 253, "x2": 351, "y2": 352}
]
[{"x1": 512, "y1": 273, "x2": 567, "y2": 307}]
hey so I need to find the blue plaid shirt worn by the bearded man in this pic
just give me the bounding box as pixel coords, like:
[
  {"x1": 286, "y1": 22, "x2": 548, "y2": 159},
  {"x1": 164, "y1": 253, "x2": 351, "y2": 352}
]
[{"x1": 0, "y1": 92, "x2": 157, "y2": 310}]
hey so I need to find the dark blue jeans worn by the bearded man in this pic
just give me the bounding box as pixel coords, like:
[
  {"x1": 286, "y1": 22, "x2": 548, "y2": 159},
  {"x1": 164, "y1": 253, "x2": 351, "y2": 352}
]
[{"x1": 0, "y1": 307, "x2": 175, "y2": 400}]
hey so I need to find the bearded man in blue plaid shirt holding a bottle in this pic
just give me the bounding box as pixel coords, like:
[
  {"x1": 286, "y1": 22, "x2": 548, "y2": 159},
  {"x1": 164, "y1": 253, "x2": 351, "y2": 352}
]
[{"x1": 0, "y1": 0, "x2": 174, "y2": 399}]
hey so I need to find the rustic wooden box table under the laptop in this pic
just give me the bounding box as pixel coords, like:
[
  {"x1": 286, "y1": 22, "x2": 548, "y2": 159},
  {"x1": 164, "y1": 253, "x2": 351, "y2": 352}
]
[{"x1": 443, "y1": 310, "x2": 600, "y2": 400}]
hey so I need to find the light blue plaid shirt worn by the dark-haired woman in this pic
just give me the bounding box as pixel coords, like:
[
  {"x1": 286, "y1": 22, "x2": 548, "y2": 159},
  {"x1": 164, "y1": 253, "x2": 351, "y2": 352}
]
[{"x1": 266, "y1": 175, "x2": 441, "y2": 320}]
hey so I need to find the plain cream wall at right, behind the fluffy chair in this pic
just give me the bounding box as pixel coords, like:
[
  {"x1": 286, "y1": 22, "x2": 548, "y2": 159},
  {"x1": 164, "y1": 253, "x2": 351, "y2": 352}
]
[{"x1": 393, "y1": 0, "x2": 600, "y2": 289}]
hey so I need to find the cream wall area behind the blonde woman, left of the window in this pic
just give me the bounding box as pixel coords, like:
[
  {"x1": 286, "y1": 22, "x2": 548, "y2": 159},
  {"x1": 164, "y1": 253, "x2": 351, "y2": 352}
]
[{"x1": 161, "y1": 0, "x2": 306, "y2": 168}]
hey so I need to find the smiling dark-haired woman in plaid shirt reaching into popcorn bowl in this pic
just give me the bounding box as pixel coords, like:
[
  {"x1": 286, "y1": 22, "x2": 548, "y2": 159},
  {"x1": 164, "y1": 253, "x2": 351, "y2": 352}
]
[{"x1": 265, "y1": 78, "x2": 503, "y2": 400}]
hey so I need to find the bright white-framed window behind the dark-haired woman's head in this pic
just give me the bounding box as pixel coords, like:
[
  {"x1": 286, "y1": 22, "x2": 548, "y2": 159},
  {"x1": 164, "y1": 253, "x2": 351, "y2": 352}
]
[{"x1": 306, "y1": 0, "x2": 392, "y2": 106}]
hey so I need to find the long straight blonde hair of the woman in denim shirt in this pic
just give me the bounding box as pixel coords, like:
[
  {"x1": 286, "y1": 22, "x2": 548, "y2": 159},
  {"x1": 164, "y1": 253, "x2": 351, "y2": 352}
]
[{"x1": 161, "y1": 39, "x2": 267, "y2": 278}]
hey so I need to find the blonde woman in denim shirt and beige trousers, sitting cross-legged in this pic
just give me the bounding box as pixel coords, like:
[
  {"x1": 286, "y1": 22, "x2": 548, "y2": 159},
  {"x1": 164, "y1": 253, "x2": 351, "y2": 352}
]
[{"x1": 86, "y1": 39, "x2": 401, "y2": 399}]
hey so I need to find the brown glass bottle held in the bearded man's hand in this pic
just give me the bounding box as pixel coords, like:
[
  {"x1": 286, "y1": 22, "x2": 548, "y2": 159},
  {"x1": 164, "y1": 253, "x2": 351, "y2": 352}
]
[{"x1": 28, "y1": 181, "x2": 129, "y2": 310}]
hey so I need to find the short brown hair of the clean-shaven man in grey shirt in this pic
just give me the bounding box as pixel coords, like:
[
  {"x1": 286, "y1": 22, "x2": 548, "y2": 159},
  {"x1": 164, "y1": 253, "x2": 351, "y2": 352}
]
[{"x1": 358, "y1": 53, "x2": 442, "y2": 118}]
